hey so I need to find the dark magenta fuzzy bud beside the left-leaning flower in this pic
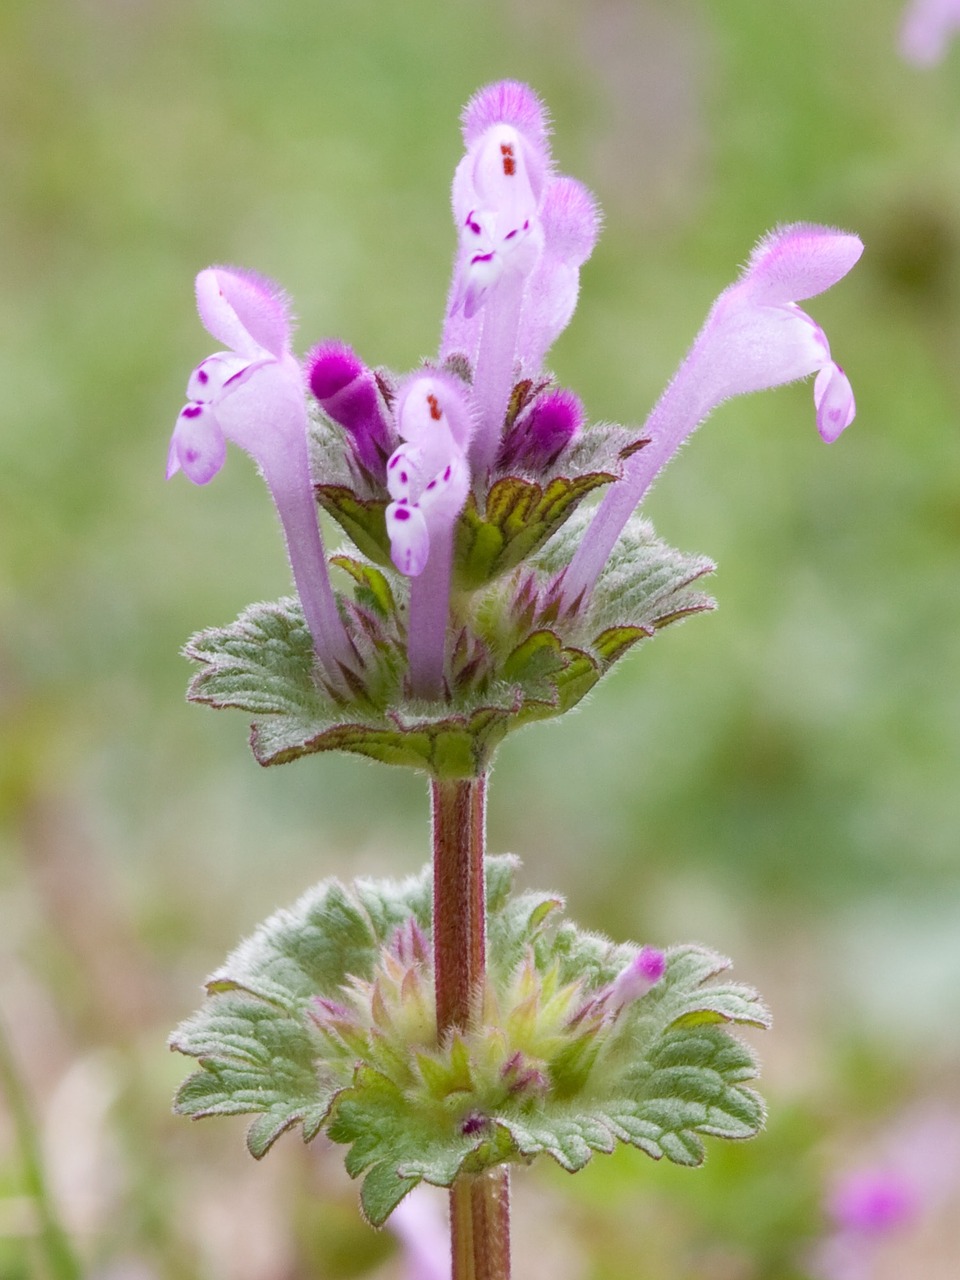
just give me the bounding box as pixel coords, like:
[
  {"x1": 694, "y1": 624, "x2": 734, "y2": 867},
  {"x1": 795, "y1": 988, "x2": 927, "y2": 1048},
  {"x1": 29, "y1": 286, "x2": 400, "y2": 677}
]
[{"x1": 307, "y1": 338, "x2": 393, "y2": 477}]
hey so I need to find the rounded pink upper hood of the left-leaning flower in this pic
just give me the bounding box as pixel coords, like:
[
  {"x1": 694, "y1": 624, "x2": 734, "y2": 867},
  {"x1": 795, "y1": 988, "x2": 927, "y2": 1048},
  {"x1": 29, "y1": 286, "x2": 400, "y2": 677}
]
[{"x1": 196, "y1": 266, "x2": 292, "y2": 360}]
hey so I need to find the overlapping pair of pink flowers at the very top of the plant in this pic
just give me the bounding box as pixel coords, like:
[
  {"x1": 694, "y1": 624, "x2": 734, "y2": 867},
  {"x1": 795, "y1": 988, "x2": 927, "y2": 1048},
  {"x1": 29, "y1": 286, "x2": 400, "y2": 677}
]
[{"x1": 440, "y1": 81, "x2": 599, "y2": 483}]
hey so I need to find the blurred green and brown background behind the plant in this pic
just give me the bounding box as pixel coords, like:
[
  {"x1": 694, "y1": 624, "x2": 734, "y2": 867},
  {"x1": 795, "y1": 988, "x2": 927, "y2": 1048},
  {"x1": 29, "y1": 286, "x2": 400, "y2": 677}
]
[{"x1": 0, "y1": 0, "x2": 960, "y2": 1280}]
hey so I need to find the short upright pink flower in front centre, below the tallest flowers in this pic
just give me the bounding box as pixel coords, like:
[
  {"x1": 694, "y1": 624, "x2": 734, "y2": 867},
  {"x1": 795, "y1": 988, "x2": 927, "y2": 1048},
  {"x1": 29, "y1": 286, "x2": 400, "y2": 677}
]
[{"x1": 387, "y1": 371, "x2": 472, "y2": 698}]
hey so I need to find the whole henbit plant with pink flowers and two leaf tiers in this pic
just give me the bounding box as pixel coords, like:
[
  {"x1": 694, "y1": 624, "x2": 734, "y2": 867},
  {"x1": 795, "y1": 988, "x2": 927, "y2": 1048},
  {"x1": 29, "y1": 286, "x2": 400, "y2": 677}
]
[{"x1": 168, "y1": 81, "x2": 863, "y2": 1280}]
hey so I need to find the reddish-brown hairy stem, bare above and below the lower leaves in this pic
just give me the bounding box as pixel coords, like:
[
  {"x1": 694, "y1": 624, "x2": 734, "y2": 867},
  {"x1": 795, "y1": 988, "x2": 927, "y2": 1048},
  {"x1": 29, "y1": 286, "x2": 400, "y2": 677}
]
[{"x1": 431, "y1": 777, "x2": 509, "y2": 1280}]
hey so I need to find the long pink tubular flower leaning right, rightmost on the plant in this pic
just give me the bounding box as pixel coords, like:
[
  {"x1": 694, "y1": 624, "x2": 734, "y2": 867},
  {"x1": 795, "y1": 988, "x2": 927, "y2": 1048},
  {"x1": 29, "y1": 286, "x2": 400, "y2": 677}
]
[{"x1": 563, "y1": 223, "x2": 863, "y2": 605}]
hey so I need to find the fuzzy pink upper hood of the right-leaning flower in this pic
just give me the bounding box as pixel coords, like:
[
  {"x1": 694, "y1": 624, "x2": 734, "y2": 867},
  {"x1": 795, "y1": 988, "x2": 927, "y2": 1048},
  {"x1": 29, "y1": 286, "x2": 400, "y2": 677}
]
[{"x1": 741, "y1": 223, "x2": 863, "y2": 306}]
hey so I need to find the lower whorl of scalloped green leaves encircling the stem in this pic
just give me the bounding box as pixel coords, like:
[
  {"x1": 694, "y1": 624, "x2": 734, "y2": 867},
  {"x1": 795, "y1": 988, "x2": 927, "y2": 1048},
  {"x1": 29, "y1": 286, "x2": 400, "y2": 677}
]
[{"x1": 172, "y1": 856, "x2": 767, "y2": 1225}]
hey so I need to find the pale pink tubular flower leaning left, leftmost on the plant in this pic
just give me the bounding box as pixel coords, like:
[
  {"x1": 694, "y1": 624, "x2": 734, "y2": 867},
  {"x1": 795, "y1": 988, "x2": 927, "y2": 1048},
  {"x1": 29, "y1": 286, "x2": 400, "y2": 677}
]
[{"x1": 166, "y1": 266, "x2": 351, "y2": 677}]
